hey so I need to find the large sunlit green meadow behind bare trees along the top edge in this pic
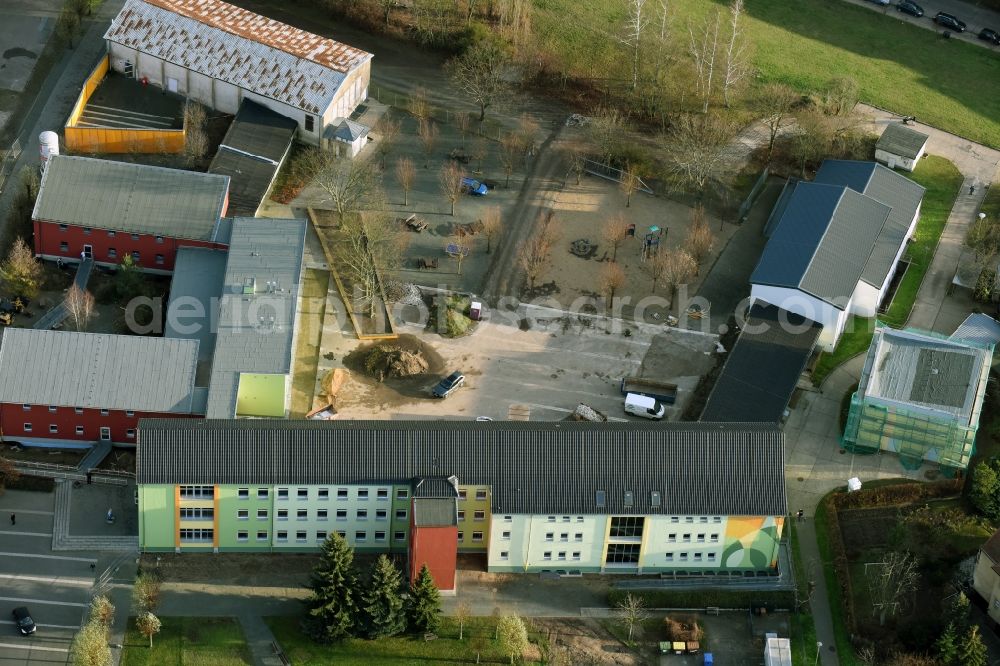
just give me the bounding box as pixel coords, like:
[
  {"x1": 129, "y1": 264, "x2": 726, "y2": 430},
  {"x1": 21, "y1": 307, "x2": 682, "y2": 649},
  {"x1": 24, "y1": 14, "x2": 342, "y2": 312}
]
[{"x1": 532, "y1": 0, "x2": 1000, "y2": 147}]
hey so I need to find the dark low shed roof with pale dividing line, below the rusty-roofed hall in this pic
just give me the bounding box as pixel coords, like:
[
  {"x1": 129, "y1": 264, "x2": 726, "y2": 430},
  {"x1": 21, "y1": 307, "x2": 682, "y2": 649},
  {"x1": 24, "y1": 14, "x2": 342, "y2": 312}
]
[{"x1": 208, "y1": 100, "x2": 298, "y2": 217}]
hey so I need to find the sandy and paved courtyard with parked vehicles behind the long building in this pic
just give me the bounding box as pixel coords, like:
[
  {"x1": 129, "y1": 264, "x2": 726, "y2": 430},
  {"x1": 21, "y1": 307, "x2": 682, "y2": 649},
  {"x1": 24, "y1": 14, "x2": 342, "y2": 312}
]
[{"x1": 322, "y1": 306, "x2": 716, "y2": 421}]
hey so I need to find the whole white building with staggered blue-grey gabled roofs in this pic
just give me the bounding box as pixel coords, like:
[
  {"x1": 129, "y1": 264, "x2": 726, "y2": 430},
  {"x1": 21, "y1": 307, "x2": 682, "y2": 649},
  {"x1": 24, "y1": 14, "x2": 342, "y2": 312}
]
[{"x1": 750, "y1": 160, "x2": 924, "y2": 351}]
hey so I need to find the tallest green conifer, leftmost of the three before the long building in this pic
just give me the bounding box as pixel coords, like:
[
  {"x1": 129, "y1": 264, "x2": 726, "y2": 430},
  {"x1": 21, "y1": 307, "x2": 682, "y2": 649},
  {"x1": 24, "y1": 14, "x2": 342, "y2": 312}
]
[{"x1": 302, "y1": 532, "x2": 358, "y2": 643}]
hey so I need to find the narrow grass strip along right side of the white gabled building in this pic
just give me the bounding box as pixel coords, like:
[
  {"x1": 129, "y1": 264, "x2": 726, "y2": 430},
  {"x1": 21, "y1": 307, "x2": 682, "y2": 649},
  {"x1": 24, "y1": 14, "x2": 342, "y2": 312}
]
[{"x1": 813, "y1": 155, "x2": 968, "y2": 386}]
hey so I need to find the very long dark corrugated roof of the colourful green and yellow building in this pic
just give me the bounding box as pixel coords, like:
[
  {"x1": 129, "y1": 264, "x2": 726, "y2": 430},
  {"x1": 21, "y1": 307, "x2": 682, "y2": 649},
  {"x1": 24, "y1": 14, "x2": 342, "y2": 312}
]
[{"x1": 136, "y1": 419, "x2": 786, "y2": 515}]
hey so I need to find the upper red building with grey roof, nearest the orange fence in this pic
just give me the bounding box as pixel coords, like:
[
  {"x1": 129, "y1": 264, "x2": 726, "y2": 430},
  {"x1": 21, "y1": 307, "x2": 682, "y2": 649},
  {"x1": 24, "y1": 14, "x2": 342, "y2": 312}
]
[{"x1": 32, "y1": 155, "x2": 231, "y2": 274}]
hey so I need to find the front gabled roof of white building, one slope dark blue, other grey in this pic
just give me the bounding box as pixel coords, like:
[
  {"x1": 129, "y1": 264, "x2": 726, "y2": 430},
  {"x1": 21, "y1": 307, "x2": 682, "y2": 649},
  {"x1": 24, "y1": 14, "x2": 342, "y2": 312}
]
[{"x1": 750, "y1": 183, "x2": 889, "y2": 310}]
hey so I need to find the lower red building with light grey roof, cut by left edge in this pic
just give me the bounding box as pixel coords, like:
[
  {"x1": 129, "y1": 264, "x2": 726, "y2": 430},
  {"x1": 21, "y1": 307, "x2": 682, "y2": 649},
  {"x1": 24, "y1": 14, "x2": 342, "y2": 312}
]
[{"x1": 0, "y1": 328, "x2": 207, "y2": 448}]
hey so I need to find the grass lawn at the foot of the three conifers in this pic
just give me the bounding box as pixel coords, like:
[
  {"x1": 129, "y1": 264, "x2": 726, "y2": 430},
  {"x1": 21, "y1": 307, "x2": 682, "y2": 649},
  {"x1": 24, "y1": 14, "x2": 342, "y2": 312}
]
[{"x1": 265, "y1": 617, "x2": 539, "y2": 666}]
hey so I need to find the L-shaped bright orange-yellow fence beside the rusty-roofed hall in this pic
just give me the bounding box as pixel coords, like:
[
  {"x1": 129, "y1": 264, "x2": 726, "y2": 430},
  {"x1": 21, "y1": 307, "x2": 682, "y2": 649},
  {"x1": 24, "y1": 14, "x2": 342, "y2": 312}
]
[{"x1": 64, "y1": 56, "x2": 185, "y2": 153}]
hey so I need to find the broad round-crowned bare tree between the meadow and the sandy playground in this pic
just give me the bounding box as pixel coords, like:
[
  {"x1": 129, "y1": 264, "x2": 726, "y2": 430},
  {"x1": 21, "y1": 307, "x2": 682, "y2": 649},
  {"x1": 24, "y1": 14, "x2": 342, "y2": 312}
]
[{"x1": 665, "y1": 113, "x2": 737, "y2": 198}]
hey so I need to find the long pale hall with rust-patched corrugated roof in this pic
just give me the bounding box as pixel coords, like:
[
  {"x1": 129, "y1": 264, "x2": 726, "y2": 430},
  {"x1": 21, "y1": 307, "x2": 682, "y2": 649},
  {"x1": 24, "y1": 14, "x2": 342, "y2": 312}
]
[{"x1": 104, "y1": 0, "x2": 372, "y2": 145}]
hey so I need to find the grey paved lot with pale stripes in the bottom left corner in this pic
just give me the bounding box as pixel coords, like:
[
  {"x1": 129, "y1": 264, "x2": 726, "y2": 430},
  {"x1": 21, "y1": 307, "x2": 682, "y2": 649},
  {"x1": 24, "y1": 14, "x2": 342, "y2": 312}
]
[{"x1": 0, "y1": 490, "x2": 94, "y2": 666}]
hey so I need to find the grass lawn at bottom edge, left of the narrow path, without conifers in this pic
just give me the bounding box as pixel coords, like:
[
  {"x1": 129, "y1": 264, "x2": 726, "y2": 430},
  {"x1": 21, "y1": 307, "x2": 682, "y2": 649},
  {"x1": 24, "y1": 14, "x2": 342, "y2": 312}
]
[{"x1": 121, "y1": 617, "x2": 253, "y2": 666}]
